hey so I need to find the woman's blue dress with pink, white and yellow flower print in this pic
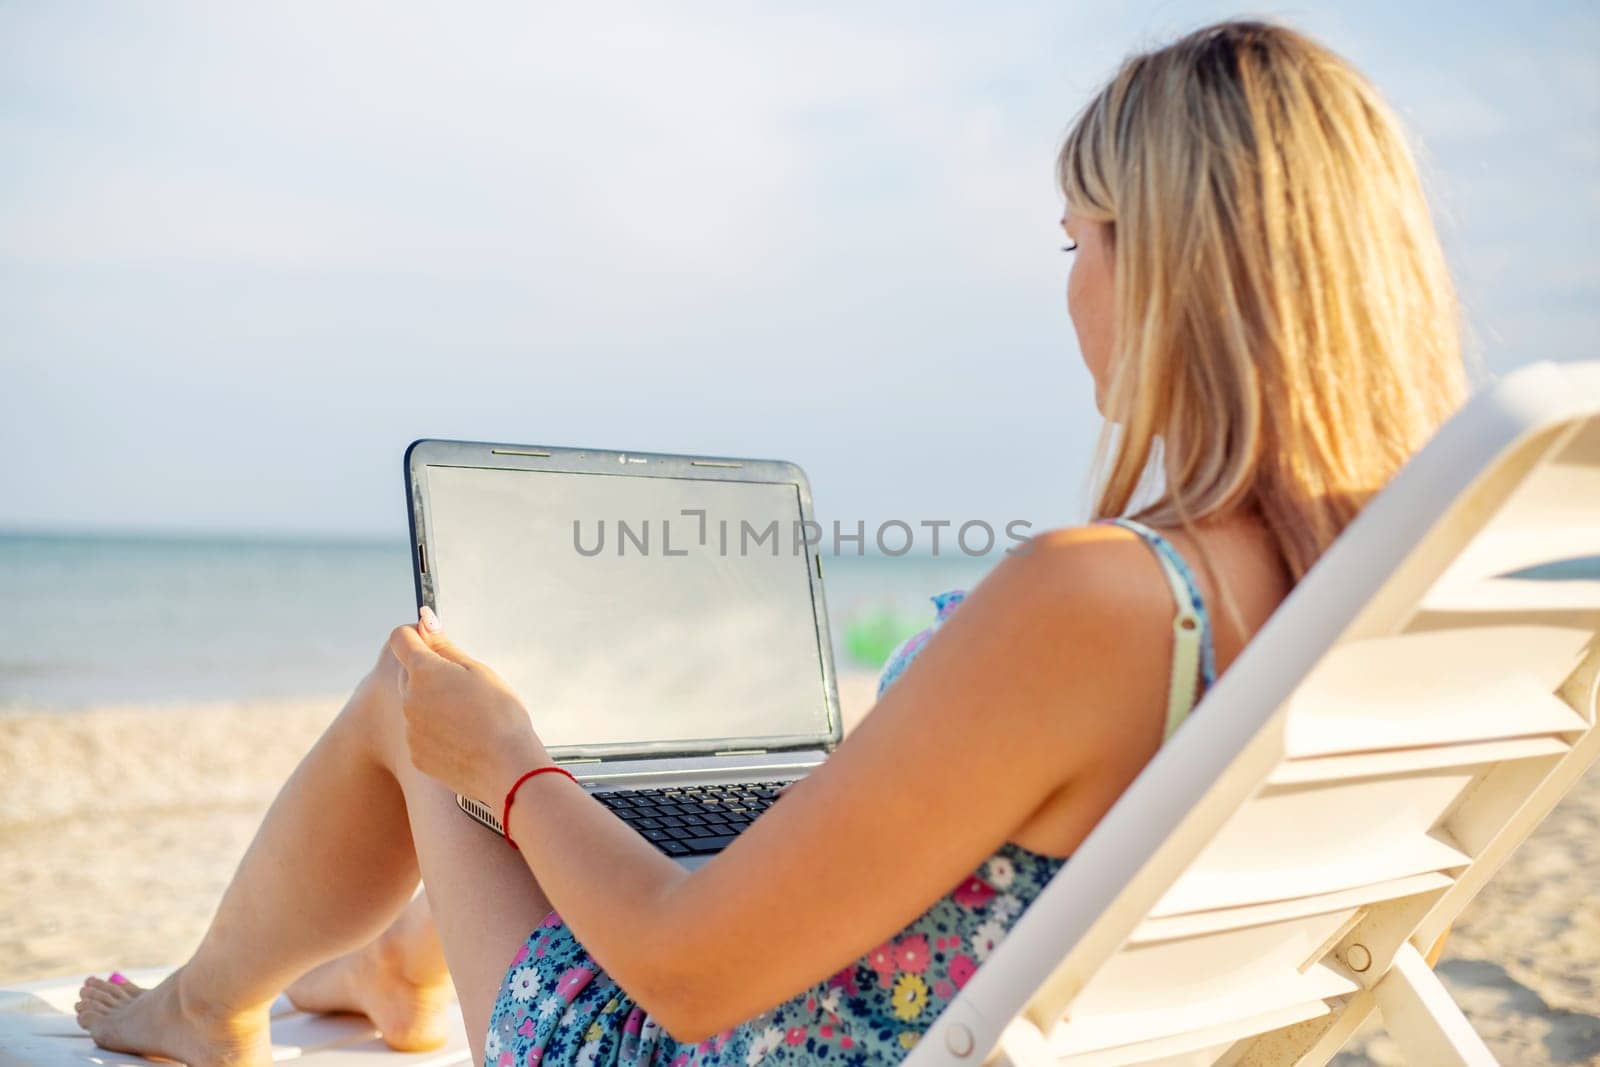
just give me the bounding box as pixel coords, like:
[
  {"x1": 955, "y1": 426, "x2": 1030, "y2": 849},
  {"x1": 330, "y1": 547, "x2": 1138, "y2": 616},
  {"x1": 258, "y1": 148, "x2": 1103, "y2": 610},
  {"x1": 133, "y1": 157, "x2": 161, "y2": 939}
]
[{"x1": 483, "y1": 524, "x2": 1210, "y2": 1067}]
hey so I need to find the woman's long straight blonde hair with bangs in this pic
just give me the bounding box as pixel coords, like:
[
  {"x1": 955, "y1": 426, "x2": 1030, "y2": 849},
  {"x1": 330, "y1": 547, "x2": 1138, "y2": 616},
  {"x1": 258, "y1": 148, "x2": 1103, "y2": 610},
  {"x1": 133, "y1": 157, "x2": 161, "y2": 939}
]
[{"x1": 1058, "y1": 21, "x2": 1467, "y2": 632}]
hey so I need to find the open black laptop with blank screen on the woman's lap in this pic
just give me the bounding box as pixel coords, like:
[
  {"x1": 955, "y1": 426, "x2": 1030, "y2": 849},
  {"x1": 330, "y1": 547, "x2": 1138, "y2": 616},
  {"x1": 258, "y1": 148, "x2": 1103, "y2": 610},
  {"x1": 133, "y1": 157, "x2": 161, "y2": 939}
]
[{"x1": 405, "y1": 440, "x2": 843, "y2": 869}]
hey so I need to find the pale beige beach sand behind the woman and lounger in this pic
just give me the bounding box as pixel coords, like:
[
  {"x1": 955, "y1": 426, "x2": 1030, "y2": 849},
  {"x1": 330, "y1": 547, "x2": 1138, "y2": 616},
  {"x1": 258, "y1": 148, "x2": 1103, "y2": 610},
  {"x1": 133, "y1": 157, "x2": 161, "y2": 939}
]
[{"x1": 0, "y1": 675, "x2": 1600, "y2": 1067}]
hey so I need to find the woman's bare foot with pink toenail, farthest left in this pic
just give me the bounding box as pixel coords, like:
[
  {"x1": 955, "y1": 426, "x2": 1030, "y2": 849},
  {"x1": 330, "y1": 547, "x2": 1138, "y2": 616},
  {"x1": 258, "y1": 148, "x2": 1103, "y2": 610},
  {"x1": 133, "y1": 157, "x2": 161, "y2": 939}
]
[{"x1": 77, "y1": 968, "x2": 272, "y2": 1067}]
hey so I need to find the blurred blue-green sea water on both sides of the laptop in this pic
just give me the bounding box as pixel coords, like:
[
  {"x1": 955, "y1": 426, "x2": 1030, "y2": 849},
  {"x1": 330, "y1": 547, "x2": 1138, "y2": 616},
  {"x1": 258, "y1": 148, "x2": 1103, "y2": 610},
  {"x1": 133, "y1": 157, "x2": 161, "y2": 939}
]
[{"x1": 0, "y1": 533, "x2": 1002, "y2": 709}]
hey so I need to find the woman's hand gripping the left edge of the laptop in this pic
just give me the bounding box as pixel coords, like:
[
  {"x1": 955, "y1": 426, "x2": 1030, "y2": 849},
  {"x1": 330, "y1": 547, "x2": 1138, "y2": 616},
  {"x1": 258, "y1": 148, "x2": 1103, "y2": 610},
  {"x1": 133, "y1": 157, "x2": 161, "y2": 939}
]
[{"x1": 389, "y1": 608, "x2": 552, "y2": 808}]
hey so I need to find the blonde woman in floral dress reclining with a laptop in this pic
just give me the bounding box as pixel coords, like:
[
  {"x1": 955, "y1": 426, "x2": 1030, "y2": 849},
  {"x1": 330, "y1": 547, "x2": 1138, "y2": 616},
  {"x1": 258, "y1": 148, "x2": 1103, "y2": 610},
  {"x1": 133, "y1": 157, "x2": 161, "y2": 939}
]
[{"x1": 78, "y1": 22, "x2": 1464, "y2": 1067}]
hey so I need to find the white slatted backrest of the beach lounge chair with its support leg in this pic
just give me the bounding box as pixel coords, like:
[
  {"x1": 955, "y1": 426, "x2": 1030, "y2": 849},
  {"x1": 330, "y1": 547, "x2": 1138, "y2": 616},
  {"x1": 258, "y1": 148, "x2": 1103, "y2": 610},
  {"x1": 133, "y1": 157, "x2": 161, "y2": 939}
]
[{"x1": 907, "y1": 363, "x2": 1600, "y2": 1067}]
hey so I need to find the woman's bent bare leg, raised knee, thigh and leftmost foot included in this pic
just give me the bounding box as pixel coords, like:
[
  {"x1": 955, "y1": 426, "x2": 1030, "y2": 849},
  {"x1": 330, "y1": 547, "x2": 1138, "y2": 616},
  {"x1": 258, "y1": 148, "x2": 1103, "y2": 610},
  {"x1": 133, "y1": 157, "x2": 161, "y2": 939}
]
[{"x1": 78, "y1": 653, "x2": 550, "y2": 1064}]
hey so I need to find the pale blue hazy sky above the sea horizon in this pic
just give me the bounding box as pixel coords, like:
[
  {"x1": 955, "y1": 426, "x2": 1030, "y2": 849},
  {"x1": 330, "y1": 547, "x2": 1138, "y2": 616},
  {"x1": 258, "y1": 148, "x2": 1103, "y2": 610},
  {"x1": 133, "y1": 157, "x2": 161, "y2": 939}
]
[{"x1": 0, "y1": 0, "x2": 1600, "y2": 541}]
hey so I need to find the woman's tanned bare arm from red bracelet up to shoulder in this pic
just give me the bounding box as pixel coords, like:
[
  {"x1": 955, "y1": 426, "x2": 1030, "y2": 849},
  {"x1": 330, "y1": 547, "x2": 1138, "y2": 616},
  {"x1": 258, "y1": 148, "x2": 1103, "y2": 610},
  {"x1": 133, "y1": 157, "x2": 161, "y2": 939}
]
[{"x1": 473, "y1": 531, "x2": 1166, "y2": 1040}]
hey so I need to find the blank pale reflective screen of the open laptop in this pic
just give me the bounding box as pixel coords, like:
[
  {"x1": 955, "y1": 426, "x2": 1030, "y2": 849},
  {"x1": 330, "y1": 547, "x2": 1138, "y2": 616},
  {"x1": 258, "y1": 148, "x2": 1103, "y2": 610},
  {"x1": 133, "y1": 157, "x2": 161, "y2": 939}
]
[{"x1": 426, "y1": 466, "x2": 829, "y2": 753}]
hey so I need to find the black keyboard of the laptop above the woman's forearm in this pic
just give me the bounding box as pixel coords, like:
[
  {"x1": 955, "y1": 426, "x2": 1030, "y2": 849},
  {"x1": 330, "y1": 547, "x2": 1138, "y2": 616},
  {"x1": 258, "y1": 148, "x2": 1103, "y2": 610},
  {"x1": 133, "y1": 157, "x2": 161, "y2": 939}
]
[{"x1": 592, "y1": 779, "x2": 792, "y2": 856}]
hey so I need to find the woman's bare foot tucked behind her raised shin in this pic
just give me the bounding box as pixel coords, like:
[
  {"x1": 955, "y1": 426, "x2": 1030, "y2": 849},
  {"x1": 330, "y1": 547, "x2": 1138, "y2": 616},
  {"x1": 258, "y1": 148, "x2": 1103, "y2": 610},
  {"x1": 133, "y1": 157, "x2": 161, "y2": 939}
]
[{"x1": 285, "y1": 929, "x2": 456, "y2": 1053}]
